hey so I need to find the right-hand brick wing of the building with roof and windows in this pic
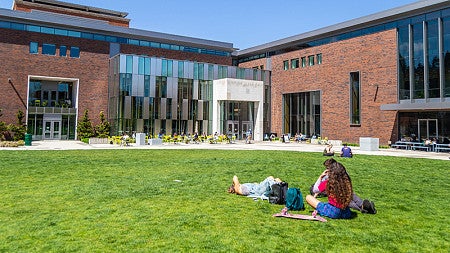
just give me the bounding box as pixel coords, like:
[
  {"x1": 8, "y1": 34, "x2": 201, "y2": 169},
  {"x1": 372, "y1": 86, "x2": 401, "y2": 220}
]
[{"x1": 234, "y1": 1, "x2": 450, "y2": 145}]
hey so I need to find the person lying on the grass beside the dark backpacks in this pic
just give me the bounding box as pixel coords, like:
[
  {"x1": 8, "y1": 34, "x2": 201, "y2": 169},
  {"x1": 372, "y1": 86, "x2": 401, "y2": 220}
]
[{"x1": 228, "y1": 175, "x2": 281, "y2": 197}]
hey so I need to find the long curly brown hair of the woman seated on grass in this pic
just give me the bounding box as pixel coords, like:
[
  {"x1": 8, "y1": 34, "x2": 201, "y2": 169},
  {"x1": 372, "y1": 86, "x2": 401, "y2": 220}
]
[{"x1": 327, "y1": 159, "x2": 353, "y2": 207}]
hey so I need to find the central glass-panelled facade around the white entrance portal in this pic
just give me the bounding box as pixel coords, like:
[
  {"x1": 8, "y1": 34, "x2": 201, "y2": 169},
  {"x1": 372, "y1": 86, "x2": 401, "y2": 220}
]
[{"x1": 108, "y1": 54, "x2": 270, "y2": 135}]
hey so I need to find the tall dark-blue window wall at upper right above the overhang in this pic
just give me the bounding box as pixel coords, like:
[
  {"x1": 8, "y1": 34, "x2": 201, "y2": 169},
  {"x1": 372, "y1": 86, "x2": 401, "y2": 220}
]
[{"x1": 397, "y1": 10, "x2": 450, "y2": 102}]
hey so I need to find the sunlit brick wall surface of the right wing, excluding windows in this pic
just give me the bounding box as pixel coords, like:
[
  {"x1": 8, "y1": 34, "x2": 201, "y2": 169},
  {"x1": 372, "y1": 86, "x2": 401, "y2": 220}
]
[{"x1": 240, "y1": 30, "x2": 398, "y2": 145}]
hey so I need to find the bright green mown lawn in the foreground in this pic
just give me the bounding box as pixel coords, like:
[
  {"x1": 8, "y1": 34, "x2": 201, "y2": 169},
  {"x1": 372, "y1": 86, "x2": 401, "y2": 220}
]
[{"x1": 0, "y1": 149, "x2": 450, "y2": 252}]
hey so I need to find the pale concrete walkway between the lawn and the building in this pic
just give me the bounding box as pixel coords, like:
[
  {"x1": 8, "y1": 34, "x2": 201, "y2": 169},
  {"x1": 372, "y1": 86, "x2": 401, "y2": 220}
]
[{"x1": 0, "y1": 140, "x2": 450, "y2": 161}]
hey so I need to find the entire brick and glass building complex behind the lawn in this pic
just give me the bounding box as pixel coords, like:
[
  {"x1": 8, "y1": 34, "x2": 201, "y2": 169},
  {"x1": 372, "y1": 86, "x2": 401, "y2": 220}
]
[{"x1": 0, "y1": 0, "x2": 450, "y2": 145}]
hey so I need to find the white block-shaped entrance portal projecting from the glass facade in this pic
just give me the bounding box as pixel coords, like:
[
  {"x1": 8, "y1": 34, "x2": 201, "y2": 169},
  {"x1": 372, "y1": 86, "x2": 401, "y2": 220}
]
[{"x1": 212, "y1": 78, "x2": 264, "y2": 141}]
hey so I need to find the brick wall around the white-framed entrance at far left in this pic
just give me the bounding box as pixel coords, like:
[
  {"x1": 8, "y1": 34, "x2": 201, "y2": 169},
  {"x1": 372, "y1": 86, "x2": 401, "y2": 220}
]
[{"x1": 0, "y1": 29, "x2": 109, "y2": 123}]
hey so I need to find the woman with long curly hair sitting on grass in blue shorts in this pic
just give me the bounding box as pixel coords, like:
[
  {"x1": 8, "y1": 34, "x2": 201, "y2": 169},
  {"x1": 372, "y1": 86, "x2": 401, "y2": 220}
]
[{"x1": 306, "y1": 159, "x2": 353, "y2": 219}]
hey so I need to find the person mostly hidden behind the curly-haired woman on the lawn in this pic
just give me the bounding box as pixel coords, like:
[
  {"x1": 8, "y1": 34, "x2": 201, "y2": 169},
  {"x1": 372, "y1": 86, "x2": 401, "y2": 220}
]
[{"x1": 309, "y1": 158, "x2": 377, "y2": 214}]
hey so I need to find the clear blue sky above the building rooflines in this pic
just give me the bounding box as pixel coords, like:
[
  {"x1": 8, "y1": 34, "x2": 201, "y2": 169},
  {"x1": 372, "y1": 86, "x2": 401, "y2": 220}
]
[{"x1": 0, "y1": 0, "x2": 417, "y2": 49}]
